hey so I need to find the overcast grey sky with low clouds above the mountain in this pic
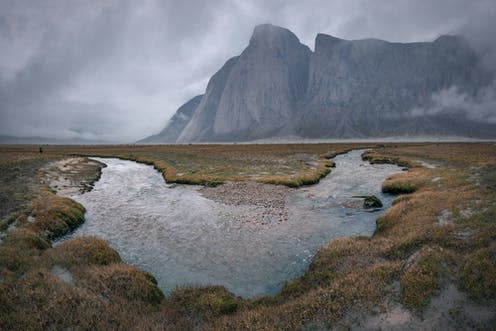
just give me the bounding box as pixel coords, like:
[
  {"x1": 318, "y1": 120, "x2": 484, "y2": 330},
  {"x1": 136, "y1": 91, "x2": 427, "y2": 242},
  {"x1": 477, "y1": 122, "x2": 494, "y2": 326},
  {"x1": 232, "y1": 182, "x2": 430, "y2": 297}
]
[{"x1": 0, "y1": 0, "x2": 496, "y2": 142}]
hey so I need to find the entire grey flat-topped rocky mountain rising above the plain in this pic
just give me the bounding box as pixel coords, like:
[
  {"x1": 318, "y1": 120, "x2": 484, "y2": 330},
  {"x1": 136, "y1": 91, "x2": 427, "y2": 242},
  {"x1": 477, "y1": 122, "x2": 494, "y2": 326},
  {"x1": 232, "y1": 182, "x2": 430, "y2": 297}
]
[{"x1": 140, "y1": 24, "x2": 496, "y2": 142}]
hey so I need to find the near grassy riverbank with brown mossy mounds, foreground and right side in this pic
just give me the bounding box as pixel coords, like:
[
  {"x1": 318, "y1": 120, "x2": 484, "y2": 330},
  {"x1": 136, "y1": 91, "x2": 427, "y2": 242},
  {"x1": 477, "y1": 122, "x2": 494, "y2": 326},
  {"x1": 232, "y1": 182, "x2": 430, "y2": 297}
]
[{"x1": 0, "y1": 144, "x2": 496, "y2": 329}]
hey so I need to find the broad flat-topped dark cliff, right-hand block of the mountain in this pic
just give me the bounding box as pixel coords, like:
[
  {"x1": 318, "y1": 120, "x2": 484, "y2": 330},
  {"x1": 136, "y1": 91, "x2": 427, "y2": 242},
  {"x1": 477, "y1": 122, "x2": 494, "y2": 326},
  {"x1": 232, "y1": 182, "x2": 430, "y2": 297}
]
[{"x1": 296, "y1": 34, "x2": 489, "y2": 138}]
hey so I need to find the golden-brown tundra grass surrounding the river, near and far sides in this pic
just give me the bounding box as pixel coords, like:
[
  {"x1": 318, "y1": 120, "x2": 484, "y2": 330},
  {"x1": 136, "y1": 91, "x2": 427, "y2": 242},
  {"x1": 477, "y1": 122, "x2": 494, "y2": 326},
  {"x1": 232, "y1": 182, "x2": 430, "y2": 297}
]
[{"x1": 0, "y1": 144, "x2": 496, "y2": 329}]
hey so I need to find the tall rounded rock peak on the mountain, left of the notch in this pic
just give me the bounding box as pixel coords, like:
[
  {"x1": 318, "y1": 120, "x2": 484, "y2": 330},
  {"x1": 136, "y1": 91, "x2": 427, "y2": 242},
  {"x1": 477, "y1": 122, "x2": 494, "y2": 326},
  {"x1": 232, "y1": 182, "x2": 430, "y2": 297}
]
[{"x1": 179, "y1": 24, "x2": 311, "y2": 141}]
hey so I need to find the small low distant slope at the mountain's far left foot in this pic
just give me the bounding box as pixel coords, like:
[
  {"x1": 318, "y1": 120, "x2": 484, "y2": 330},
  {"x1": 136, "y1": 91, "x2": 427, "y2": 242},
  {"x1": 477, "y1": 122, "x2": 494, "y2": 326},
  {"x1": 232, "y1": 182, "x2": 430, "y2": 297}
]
[{"x1": 138, "y1": 94, "x2": 203, "y2": 144}]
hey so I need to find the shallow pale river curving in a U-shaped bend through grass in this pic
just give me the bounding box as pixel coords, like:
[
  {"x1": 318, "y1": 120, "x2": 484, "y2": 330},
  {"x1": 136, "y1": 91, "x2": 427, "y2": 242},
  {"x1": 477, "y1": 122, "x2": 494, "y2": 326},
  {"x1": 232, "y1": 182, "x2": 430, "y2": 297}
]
[{"x1": 58, "y1": 150, "x2": 401, "y2": 297}]
